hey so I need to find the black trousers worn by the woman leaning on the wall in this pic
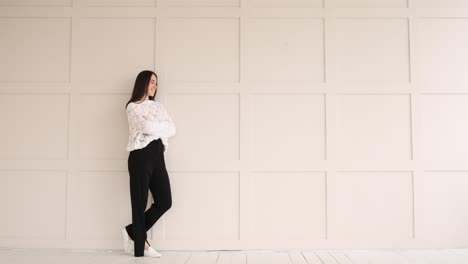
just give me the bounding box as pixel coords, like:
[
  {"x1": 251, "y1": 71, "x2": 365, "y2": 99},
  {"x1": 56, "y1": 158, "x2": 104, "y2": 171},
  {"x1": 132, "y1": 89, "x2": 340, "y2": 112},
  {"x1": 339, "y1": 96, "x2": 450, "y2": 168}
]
[{"x1": 125, "y1": 139, "x2": 172, "y2": 257}]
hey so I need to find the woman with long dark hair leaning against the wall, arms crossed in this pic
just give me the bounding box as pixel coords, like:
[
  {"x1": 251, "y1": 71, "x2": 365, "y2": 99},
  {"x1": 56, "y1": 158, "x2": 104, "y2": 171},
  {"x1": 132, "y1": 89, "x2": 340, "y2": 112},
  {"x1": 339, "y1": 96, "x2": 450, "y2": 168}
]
[{"x1": 122, "y1": 71, "x2": 176, "y2": 257}]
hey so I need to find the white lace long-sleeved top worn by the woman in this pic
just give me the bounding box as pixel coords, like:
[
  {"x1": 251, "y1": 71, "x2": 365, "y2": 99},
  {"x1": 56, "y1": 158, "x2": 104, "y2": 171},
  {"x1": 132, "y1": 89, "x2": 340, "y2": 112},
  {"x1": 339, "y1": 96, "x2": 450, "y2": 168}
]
[{"x1": 127, "y1": 100, "x2": 176, "y2": 152}]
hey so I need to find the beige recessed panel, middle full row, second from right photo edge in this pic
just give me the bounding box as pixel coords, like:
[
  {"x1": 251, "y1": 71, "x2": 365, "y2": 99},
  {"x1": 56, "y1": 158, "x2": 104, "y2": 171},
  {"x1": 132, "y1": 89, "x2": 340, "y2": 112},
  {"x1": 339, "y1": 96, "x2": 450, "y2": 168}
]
[{"x1": 336, "y1": 94, "x2": 412, "y2": 163}]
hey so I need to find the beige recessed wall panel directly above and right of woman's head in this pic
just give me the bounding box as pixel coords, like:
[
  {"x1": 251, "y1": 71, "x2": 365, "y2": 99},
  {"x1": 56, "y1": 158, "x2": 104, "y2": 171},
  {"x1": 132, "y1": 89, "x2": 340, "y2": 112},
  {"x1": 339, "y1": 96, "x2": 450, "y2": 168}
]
[{"x1": 157, "y1": 18, "x2": 239, "y2": 83}]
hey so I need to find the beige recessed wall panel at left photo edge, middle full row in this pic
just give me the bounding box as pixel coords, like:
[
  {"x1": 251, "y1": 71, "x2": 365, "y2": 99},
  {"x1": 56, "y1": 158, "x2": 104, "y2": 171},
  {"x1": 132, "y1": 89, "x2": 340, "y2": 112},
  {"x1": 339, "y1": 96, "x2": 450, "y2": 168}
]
[{"x1": 0, "y1": 94, "x2": 69, "y2": 160}]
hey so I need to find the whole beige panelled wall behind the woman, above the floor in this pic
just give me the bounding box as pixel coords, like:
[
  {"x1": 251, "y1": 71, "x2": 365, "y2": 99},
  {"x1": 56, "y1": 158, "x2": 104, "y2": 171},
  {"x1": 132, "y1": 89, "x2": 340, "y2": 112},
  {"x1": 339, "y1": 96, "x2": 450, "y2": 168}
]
[{"x1": 0, "y1": 0, "x2": 468, "y2": 250}]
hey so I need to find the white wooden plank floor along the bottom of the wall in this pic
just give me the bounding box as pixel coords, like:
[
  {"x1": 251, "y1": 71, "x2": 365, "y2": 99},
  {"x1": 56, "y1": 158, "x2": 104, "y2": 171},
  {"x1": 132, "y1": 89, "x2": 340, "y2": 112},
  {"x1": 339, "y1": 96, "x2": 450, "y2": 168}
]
[{"x1": 0, "y1": 249, "x2": 468, "y2": 264}]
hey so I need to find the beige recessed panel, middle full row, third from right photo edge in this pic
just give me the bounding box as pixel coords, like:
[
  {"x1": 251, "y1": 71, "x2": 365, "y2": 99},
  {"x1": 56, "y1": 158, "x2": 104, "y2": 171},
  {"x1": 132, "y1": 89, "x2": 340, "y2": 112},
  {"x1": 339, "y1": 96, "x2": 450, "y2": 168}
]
[{"x1": 251, "y1": 94, "x2": 325, "y2": 169}]
